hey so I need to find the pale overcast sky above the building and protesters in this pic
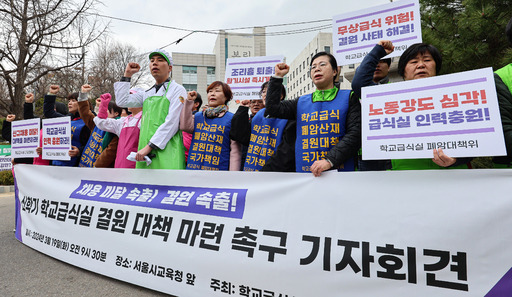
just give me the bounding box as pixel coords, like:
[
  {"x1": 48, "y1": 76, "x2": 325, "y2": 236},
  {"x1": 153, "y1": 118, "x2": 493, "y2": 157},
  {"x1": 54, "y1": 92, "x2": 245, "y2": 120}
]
[{"x1": 96, "y1": 0, "x2": 390, "y2": 62}]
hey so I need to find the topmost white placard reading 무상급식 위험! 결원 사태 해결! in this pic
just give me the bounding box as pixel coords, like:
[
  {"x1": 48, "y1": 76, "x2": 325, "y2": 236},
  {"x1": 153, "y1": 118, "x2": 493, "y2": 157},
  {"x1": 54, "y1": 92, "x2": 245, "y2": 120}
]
[{"x1": 332, "y1": 0, "x2": 422, "y2": 66}]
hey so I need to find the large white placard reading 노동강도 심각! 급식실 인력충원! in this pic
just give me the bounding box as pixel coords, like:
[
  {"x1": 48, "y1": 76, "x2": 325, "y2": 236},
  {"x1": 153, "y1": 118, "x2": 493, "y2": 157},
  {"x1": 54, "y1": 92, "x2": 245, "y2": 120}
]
[{"x1": 361, "y1": 68, "x2": 506, "y2": 160}]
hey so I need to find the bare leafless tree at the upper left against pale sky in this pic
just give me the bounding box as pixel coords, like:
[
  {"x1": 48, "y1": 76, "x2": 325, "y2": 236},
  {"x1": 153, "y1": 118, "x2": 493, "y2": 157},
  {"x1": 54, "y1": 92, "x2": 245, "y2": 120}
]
[{"x1": 0, "y1": 0, "x2": 106, "y2": 118}]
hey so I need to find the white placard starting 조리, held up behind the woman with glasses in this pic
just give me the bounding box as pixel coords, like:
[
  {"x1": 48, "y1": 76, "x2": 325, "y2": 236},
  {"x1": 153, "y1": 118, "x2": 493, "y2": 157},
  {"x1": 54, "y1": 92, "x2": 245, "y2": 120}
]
[{"x1": 224, "y1": 56, "x2": 284, "y2": 100}]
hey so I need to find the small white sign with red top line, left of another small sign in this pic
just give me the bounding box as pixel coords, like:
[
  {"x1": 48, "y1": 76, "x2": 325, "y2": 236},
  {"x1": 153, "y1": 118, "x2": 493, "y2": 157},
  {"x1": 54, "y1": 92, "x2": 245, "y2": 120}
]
[{"x1": 11, "y1": 118, "x2": 41, "y2": 158}]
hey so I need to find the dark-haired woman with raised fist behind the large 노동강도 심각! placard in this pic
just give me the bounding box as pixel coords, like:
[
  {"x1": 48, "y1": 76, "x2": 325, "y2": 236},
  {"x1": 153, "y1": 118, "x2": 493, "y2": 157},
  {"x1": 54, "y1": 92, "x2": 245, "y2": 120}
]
[{"x1": 352, "y1": 40, "x2": 471, "y2": 170}]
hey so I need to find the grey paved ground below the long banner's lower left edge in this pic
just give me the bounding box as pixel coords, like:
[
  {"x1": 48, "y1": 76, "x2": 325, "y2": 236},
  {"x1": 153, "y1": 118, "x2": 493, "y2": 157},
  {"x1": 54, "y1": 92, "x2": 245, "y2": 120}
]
[{"x1": 0, "y1": 193, "x2": 174, "y2": 297}]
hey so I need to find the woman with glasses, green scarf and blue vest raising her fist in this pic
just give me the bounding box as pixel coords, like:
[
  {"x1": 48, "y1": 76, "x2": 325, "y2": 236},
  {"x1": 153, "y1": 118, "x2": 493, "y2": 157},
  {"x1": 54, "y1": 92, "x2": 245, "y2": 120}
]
[{"x1": 265, "y1": 52, "x2": 361, "y2": 176}]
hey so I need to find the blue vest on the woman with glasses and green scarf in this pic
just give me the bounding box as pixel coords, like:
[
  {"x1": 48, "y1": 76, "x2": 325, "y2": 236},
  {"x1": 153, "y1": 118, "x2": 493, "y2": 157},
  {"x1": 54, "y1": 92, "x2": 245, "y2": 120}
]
[{"x1": 295, "y1": 90, "x2": 354, "y2": 172}]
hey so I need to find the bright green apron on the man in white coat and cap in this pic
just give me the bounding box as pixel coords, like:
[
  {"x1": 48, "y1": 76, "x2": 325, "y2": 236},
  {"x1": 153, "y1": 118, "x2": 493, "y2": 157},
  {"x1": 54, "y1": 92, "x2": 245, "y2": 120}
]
[{"x1": 135, "y1": 83, "x2": 185, "y2": 169}]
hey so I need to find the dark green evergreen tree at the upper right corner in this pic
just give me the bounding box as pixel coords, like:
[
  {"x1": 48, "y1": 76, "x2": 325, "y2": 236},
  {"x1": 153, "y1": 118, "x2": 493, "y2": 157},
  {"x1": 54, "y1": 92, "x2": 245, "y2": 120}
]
[{"x1": 420, "y1": 0, "x2": 512, "y2": 74}]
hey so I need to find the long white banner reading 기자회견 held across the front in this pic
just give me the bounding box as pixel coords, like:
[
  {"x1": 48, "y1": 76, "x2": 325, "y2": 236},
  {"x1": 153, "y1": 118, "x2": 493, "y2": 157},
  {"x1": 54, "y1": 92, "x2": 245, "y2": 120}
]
[{"x1": 15, "y1": 165, "x2": 512, "y2": 297}]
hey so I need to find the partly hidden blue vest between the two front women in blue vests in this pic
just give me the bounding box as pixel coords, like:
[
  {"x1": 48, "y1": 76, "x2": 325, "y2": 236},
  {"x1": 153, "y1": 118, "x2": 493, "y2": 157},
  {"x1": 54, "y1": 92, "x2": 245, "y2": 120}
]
[{"x1": 244, "y1": 108, "x2": 288, "y2": 171}]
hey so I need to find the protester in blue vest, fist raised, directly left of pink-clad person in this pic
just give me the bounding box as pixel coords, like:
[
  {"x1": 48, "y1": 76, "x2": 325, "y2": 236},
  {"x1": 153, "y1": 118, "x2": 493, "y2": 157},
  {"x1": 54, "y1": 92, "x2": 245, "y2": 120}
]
[{"x1": 78, "y1": 84, "x2": 122, "y2": 168}]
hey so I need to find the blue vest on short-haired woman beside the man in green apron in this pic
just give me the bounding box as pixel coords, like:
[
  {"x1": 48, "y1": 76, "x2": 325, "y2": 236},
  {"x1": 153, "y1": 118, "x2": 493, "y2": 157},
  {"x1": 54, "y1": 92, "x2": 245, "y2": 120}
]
[{"x1": 187, "y1": 112, "x2": 233, "y2": 170}]
